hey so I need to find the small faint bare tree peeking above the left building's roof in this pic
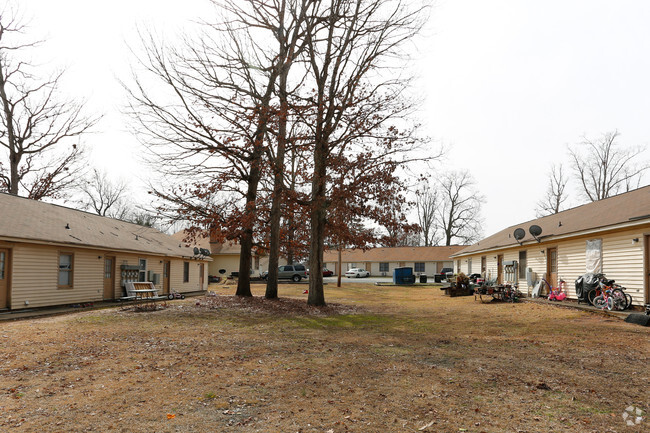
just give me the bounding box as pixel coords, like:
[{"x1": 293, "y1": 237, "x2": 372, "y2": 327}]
[{"x1": 80, "y1": 169, "x2": 129, "y2": 219}]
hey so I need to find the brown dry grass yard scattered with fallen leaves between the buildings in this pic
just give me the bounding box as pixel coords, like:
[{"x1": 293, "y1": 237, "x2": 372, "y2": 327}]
[{"x1": 0, "y1": 284, "x2": 650, "y2": 433}]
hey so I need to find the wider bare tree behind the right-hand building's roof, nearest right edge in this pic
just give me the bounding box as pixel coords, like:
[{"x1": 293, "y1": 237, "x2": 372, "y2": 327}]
[{"x1": 569, "y1": 130, "x2": 648, "y2": 201}]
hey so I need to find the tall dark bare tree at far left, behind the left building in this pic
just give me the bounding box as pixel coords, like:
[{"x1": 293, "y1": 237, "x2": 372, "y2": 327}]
[{"x1": 0, "y1": 7, "x2": 98, "y2": 200}]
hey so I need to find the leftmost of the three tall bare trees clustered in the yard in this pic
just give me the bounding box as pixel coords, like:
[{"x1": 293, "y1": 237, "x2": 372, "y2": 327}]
[{"x1": 128, "y1": 0, "x2": 298, "y2": 296}]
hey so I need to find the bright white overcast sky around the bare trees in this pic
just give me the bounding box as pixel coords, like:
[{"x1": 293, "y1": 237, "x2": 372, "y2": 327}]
[{"x1": 19, "y1": 0, "x2": 650, "y2": 235}]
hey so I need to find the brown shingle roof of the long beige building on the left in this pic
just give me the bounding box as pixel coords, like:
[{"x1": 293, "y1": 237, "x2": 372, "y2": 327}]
[{"x1": 0, "y1": 193, "x2": 194, "y2": 257}]
